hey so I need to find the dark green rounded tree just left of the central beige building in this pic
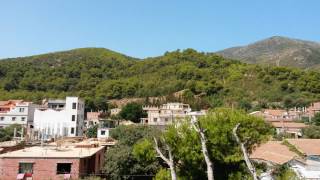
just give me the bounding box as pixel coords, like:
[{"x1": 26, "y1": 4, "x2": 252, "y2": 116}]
[{"x1": 119, "y1": 102, "x2": 146, "y2": 123}]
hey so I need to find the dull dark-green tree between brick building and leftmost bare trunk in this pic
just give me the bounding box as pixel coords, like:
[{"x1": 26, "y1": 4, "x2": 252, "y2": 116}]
[{"x1": 104, "y1": 125, "x2": 161, "y2": 179}]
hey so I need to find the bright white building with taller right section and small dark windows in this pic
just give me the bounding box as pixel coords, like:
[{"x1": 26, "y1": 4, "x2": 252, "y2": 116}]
[{"x1": 34, "y1": 97, "x2": 84, "y2": 139}]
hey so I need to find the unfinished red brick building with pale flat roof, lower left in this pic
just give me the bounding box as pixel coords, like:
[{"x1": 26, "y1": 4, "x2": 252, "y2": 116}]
[{"x1": 0, "y1": 146, "x2": 105, "y2": 180}]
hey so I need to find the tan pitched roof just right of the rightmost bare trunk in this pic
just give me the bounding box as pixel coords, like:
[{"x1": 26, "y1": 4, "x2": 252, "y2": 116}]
[{"x1": 250, "y1": 141, "x2": 298, "y2": 164}]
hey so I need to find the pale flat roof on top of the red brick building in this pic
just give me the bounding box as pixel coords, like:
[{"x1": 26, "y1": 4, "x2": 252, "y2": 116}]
[{"x1": 0, "y1": 146, "x2": 104, "y2": 158}]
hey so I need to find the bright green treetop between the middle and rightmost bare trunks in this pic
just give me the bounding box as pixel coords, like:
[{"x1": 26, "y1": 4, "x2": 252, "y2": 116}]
[{"x1": 200, "y1": 108, "x2": 272, "y2": 163}]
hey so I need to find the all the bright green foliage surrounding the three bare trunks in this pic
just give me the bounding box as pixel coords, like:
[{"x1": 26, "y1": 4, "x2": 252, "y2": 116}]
[{"x1": 133, "y1": 109, "x2": 272, "y2": 180}]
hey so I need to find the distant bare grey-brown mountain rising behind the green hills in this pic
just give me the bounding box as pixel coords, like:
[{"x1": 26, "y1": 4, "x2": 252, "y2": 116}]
[{"x1": 217, "y1": 36, "x2": 320, "y2": 68}]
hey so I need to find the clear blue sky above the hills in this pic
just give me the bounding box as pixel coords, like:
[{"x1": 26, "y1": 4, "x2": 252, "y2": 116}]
[{"x1": 0, "y1": 0, "x2": 320, "y2": 58}]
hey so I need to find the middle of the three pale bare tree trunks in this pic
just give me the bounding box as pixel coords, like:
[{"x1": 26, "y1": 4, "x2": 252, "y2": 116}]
[{"x1": 191, "y1": 117, "x2": 214, "y2": 180}]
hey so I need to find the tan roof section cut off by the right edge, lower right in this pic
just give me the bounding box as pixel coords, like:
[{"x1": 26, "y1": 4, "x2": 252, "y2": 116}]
[{"x1": 288, "y1": 139, "x2": 320, "y2": 155}]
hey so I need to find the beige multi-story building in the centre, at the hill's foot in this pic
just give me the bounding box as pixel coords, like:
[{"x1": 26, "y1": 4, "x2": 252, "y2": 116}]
[{"x1": 141, "y1": 103, "x2": 191, "y2": 125}]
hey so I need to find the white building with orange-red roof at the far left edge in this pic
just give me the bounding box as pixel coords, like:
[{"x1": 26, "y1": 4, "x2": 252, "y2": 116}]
[{"x1": 0, "y1": 100, "x2": 37, "y2": 128}]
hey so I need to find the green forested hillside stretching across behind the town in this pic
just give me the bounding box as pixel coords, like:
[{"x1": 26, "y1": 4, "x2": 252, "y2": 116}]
[{"x1": 0, "y1": 48, "x2": 320, "y2": 109}]
